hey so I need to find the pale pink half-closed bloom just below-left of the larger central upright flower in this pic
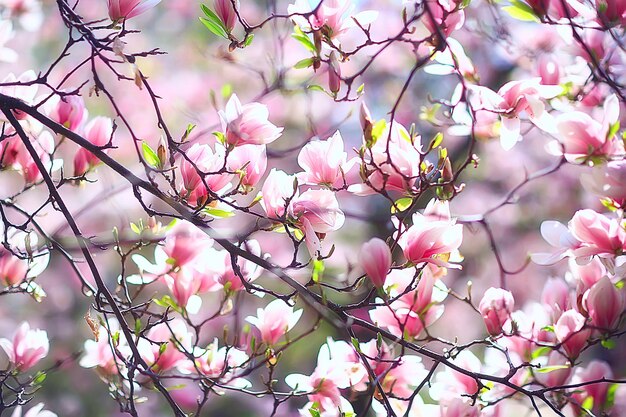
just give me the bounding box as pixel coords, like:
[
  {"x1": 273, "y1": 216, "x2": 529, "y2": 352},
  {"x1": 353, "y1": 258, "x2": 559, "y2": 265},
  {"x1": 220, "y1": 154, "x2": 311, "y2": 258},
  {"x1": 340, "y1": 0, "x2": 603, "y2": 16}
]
[{"x1": 261, "y1": 168, "x2": 298, "y2": 219}]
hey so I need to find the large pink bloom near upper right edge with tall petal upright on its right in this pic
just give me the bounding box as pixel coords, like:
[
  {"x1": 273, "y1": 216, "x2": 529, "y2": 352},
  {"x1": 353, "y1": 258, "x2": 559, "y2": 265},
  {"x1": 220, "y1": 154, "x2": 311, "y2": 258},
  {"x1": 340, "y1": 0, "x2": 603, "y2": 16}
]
[{"x1": 549, "y1": 95, "x2": 624, "y2": 162}]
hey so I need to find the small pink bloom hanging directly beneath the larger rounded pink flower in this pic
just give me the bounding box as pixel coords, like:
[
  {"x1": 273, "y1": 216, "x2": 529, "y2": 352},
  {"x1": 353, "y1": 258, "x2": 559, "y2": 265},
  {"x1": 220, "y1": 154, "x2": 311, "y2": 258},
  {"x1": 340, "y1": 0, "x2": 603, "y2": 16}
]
[{"x1": 225, "y1": 143, "x2": 267, "y2": 191}]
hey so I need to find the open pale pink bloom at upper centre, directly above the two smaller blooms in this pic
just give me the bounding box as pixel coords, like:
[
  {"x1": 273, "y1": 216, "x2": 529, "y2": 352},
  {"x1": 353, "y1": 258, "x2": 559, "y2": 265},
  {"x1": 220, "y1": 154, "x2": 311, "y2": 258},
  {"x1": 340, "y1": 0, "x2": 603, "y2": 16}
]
[{"x1": 298, "y1": 131, "x2": 356, "y2": 188}]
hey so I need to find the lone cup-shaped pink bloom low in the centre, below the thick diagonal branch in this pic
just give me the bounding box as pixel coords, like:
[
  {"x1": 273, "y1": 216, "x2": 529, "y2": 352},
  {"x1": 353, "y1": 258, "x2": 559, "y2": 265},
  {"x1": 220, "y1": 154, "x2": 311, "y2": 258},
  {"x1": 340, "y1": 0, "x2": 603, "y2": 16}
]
[{"x1": 246, "y1": 299, "x2": 302, "y2": 346}]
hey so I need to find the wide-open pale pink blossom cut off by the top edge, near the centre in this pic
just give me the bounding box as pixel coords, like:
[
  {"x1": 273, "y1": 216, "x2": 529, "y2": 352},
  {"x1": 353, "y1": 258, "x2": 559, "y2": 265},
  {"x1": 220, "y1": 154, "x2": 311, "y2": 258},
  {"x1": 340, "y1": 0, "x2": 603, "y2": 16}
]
[{"x1": 287, "y1": 0, "x2": 378, "y2": 38}]
